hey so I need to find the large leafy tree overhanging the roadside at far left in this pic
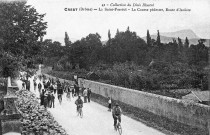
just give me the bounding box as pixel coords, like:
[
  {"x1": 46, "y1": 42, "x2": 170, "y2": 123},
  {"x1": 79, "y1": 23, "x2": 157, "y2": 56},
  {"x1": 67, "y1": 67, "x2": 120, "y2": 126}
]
[{"x1": 0, "y1": 2, "x2": 47, "y2": 76}]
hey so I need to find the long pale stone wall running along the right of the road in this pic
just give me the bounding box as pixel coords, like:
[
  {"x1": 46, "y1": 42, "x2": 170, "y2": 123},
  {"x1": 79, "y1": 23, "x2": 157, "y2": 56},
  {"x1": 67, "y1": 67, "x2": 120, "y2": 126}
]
[{"x1": 79, "y1": 79, "x2": 210, "y2": 129}]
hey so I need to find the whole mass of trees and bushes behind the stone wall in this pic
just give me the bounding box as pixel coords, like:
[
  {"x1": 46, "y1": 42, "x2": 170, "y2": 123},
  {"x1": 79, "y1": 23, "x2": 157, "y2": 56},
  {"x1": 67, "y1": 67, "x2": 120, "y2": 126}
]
[{"x1": 44, "y1": 27, "x2": 208, "y2": 93}]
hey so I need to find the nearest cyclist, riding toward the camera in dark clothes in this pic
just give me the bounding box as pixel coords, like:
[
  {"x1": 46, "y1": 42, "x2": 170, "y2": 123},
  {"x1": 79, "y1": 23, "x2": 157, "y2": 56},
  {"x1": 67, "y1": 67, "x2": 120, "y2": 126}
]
[{"x1": 112, "y1": 103, "x2": 122, "y2": 129}]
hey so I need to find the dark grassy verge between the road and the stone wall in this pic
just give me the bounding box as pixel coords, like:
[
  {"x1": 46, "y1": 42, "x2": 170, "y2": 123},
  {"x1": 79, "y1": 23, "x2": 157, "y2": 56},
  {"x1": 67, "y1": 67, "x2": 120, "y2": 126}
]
[{"x1": 91, "y1": 93, "x2": 208, "y2": 135}]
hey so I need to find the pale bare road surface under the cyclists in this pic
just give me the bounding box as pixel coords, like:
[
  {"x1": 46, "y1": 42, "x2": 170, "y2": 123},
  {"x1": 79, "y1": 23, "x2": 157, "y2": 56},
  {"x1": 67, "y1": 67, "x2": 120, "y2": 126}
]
[{"x1": 15, "y1": 72, "x2": 164, "y2": 135}]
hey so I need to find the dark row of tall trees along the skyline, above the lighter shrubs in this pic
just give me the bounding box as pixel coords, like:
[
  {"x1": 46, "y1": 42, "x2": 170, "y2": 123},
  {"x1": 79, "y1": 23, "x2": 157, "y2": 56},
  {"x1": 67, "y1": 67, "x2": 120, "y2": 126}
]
[{"x1": 42, "y1": 27, "x2": 208, "y2": 70}]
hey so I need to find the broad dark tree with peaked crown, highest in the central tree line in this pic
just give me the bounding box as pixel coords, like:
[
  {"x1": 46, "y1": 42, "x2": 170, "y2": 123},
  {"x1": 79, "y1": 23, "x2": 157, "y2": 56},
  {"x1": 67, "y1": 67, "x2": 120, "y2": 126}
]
[{"x1": 103, "y1": 27, "x2": 147, "y2": 64}]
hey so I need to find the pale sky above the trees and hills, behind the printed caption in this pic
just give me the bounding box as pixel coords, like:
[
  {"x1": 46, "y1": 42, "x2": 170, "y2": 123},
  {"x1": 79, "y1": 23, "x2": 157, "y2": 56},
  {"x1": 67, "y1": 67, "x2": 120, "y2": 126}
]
[{"x1": 27, "y1": 0, "x2": 210, "y2": 44}]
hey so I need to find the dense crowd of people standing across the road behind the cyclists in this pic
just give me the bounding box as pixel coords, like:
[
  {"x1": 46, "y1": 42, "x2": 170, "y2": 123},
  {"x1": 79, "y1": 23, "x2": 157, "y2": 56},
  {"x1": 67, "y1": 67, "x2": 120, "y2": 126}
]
[{"x1": 33, "y1": 76, "x2": 91, "y2": 108}]
